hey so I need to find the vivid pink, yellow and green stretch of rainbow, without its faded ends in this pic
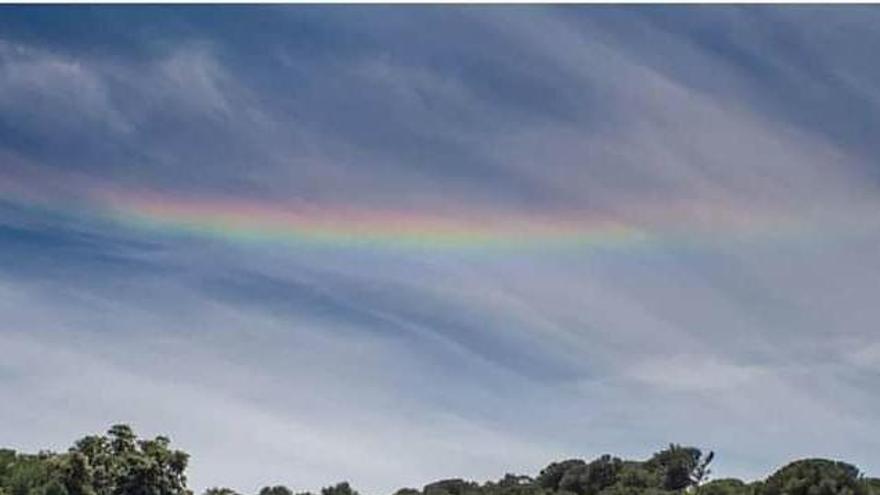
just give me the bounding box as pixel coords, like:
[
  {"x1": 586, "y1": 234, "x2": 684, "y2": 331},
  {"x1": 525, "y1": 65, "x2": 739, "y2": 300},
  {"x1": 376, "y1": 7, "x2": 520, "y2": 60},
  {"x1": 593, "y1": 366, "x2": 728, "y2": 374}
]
[{"x1": 101, "y1": 195, "x2": 646, "y2": 254}]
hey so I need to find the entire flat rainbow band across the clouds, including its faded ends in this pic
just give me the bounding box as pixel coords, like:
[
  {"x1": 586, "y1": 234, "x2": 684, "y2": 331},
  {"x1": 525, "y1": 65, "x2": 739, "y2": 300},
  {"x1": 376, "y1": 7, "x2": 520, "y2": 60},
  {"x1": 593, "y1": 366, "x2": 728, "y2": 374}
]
[{"x1": 0, "y1": 177, "x2": 880, "y2": 252}]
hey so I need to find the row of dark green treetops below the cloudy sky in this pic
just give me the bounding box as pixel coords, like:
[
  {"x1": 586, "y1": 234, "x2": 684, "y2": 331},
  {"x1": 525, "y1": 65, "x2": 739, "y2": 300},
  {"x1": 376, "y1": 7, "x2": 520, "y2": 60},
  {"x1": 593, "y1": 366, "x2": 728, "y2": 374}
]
[{"x1": 0, "y1": 425, "x2": 880, "y2": 495}]
